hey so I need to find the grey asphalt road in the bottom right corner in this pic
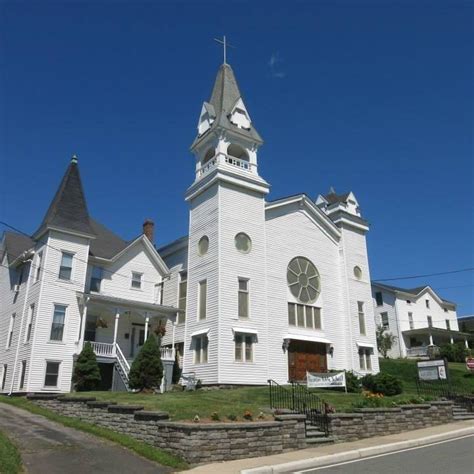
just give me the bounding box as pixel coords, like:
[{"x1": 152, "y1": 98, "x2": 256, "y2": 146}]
[{"x1": 302, "y1": 435, "x2": 474, "y2": 474}]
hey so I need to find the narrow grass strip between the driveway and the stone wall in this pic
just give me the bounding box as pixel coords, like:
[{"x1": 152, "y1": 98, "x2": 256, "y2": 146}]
[{"x1": 0, "y1": 396, "x2": 188, "y2": 474}]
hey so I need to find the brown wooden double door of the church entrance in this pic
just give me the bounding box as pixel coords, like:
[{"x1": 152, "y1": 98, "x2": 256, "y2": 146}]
[{"x1": 288, "y1": 339, "x2": 327, "y2": 382}]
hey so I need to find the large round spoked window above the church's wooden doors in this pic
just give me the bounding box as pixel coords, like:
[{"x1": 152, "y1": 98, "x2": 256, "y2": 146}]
[{"x1": 286, "y1": 257, "x2": 321, "y2": 303}]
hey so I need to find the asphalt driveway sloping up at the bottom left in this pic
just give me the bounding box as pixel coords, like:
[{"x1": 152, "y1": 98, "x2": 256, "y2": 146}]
[{"x1": 0, "y1": 403, "x2": 172, "y2": 474}]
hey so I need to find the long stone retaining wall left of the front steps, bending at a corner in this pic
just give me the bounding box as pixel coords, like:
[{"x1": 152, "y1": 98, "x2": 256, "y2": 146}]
[{"x1": 29, "y1": 395, "x2": 306, "y2": 464}]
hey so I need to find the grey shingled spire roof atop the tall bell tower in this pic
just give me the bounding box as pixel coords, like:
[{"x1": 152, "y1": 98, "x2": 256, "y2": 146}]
[{"x1": 191, "y1": 63, "x2": 263, "y2": 148}]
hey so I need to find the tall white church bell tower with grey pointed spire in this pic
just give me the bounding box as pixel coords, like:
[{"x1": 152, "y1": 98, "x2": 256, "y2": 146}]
[{"x1": 183, "y1": 60, "x2": 269, "y2": 384}]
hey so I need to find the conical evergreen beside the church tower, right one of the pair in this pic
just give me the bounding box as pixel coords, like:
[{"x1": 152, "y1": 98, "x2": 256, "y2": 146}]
[{"x1": 128, "y1": 334, "x2": 163, "y2": 390}]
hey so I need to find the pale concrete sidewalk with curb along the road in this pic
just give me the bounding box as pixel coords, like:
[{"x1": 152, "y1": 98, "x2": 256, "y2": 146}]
[{"x1": 188, "y1": 420, "x2": 474, "y2": 474}]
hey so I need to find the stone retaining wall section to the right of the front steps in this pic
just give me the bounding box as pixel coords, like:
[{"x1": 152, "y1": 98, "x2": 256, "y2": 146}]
[{"x1": 329, "y1": 401, "x2": 453, "y2": 441}]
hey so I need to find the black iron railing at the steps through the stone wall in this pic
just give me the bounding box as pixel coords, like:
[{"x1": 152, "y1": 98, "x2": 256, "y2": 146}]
[{"x1": 268, "y1": 380, "x2": 329, "y2": 434}]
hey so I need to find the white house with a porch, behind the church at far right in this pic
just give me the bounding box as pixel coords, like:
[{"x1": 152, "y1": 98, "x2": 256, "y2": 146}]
[{"x1": 372, "y1": 282, "x2": 472, "y2": 357}]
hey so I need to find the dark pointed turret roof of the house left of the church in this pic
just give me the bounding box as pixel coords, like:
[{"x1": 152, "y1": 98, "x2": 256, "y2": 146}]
[{"x1": 33, "y1": 157, "x2": 95, "y2": 237}]
